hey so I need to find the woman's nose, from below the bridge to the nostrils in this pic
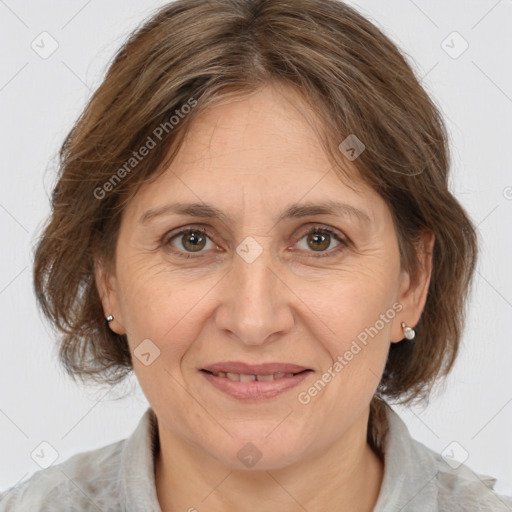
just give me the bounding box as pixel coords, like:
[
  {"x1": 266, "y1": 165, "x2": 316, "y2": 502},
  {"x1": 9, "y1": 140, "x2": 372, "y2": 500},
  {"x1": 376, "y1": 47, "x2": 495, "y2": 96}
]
[{"x1": 216, "y1": 241, "x2": 294, "y2": 345}]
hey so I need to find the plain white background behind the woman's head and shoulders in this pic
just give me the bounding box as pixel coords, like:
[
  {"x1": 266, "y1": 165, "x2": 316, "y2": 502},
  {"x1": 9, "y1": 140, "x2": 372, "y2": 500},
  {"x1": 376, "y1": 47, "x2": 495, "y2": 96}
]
[{"x1": 0, "y1": 0, "x2": 512, "y2": 495}]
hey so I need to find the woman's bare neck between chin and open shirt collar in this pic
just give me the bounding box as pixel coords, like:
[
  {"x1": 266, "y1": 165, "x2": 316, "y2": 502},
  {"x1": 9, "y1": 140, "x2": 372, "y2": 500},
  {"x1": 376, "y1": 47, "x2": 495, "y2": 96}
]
[{"x1": 155, "y1": 409, "x2": 384, "y2": 512}]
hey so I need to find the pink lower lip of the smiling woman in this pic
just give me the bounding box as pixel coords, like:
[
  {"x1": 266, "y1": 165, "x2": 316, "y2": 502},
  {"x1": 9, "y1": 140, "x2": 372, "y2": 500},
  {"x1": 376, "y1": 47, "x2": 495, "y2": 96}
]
[{"x1": 201, "y1": 371, "x2": 312, "y2": 400}]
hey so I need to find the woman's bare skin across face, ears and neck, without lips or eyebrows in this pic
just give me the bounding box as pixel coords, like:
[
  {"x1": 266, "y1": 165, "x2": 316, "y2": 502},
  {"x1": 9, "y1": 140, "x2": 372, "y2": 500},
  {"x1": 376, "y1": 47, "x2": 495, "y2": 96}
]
[{"x1": 96, "y1": 86, "x2": 433, "y2": 512}]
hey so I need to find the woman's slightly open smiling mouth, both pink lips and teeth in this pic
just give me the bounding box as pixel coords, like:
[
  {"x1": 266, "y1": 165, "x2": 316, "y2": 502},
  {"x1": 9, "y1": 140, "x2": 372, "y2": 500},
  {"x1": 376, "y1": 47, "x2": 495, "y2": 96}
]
[{"x1": 200, "y1": 363, "x2": 313, "y2": 401}]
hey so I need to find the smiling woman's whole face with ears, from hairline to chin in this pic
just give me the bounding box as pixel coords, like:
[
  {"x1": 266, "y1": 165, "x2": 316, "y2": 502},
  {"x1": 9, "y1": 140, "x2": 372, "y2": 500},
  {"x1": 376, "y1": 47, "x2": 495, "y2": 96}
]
[{"x1": 98, "y1": 87, "x2": 428, "y2": 469}]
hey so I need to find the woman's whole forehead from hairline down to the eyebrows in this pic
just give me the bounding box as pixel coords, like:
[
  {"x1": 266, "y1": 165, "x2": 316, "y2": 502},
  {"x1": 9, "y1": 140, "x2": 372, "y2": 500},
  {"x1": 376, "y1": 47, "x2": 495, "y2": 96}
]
[{"x1": 127, "y1": 87, "x2": 379, "y2": 224}]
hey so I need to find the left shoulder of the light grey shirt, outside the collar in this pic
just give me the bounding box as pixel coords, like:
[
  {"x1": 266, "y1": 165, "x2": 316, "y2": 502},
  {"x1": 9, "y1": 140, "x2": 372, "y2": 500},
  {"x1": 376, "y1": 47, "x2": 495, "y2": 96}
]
[{"x1": 0, "y1": 440, "x2": 126, "y2": 512}]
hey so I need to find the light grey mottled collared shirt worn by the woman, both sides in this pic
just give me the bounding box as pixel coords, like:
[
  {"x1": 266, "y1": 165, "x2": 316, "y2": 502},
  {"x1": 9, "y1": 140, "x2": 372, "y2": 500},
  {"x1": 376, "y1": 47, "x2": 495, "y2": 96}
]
[{"x1": 0, "y1": 406, "x2": 512, "y2": 512}]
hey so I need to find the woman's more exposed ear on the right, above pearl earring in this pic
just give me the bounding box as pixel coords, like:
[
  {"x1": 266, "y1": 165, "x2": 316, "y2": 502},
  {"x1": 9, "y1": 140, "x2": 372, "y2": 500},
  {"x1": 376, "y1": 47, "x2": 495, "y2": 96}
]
[{"x1": 391, "y1": 231, "x2": 435, "y2": 343}]
